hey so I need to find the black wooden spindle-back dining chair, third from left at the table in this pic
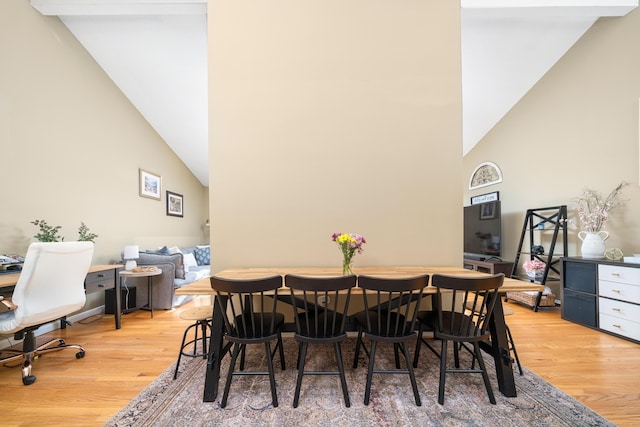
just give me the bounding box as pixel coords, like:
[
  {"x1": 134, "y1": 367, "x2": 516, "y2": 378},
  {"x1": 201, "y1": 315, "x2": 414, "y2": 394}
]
[{"x1": 353, "y1": 274, "x2": 429, "y2": 406}]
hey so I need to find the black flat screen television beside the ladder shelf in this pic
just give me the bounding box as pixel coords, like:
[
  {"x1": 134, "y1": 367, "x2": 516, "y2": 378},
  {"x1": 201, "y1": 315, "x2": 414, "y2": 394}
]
[{"x1": 464, "y1": 200, "x2": 502, "y2": 261}]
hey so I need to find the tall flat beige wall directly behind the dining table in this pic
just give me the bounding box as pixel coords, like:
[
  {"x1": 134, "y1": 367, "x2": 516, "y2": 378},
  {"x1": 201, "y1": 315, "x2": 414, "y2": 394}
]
[{"x1": 209, "y1": 0, "x2": 462, "y2": 271}]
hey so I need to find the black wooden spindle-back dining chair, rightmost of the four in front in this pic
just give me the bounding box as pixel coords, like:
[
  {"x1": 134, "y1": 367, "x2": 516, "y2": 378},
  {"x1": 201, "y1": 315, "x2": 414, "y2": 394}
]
[{"x1": 416, "y1": 273, "x2": 504, "y2": 405}]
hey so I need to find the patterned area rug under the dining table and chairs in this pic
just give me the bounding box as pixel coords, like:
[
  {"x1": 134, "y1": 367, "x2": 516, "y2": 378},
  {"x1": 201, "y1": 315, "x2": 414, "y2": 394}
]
[{"x1": 105, "y1": 338, "x2": 613, "y2": 427}]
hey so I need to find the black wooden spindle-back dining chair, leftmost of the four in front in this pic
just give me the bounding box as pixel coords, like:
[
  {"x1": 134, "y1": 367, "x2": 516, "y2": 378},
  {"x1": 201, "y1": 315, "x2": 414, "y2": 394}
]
[{"x1": 211, "y1": 276, "x2": 285, "y2": 408}]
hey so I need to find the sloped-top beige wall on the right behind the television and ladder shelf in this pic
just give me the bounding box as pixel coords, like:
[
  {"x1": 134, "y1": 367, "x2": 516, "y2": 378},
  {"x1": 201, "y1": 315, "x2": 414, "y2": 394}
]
[{"x1": 462, "y1": 10, "x2": 640, "y2": 298}]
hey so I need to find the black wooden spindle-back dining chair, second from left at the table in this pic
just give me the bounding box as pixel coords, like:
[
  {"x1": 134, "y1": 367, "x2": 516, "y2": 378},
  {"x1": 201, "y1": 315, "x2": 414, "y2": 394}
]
[{"x1": 284, "y1": 274, "x2": 356, "y2": 408}]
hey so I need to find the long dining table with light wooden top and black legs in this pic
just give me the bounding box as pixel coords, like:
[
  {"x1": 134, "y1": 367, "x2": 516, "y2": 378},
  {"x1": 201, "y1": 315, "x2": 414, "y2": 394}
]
[{"x1": 176, "y1": 267, "x2": 543, "y2": 402}]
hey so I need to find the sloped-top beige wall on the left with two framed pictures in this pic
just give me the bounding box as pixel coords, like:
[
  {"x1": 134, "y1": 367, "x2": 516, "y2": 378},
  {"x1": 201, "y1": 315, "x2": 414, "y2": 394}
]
[{"x1": 0, "y1": 0, "x2": 208, "y2": 263}]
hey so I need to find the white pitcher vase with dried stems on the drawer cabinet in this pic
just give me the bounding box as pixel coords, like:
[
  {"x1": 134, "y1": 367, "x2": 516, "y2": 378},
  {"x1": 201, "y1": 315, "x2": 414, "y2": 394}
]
[{"x1": 576, "y1": 181, "x2": 629, "y2": 259}]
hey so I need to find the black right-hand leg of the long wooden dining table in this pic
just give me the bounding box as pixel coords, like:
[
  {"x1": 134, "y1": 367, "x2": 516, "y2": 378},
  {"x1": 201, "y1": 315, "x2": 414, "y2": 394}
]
[{"x1": 489, "y1": 296, "x2": 517, "y2": 397}]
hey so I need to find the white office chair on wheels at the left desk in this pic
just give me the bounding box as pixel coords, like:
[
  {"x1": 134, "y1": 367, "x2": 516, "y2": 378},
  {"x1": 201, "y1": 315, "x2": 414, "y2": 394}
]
[{"x1": 0, "y1": 242, "x2": 93, "y2": 385}]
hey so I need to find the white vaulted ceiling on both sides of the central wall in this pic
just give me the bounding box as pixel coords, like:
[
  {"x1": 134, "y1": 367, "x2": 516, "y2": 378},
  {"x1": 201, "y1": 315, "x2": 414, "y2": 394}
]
[{"x1": 31, "y1": 0, "x2": 638, "y2": 186}]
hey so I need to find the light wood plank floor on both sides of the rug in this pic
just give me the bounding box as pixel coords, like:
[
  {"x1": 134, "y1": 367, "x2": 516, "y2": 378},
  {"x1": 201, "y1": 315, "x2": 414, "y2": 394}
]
[{"x1": 0, "y1": 298, "x2": 640, "y2": 426}]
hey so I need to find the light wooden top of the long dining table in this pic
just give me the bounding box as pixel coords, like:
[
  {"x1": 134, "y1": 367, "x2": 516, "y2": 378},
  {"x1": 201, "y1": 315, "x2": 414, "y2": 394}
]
[{"x1": 175, "y1": 266, "x2": 544, "y2": 295}]
